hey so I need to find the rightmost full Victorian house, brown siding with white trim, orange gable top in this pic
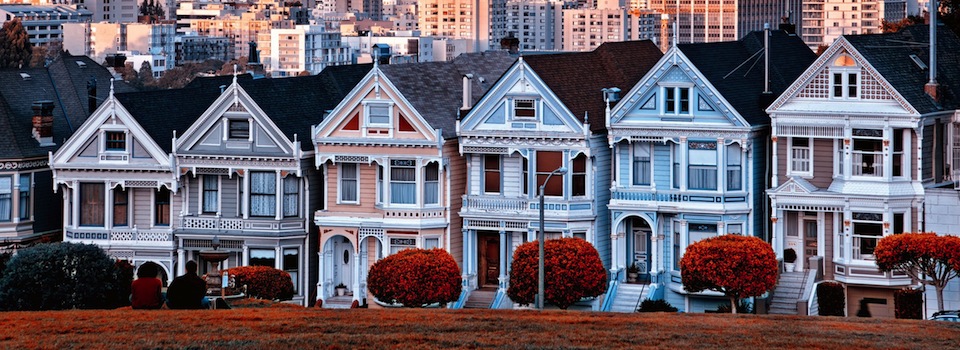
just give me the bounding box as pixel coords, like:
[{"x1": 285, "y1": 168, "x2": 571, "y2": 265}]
[{"x1": 767, "y1": 26, "x2": 960, "y2": 317}]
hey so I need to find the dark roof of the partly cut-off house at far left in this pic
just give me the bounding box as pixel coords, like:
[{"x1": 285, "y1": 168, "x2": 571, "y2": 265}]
[{"x1": 0, "y1": 55, "x2": 135, "y2": 159}]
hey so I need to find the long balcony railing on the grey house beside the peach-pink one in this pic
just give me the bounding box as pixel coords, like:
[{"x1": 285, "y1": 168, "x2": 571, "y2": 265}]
[{"x1": 177, "y1": 216, "x2": 307, "y2": 234}]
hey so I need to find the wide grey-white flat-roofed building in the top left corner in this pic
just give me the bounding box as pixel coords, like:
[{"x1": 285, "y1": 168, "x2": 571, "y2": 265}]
[{"x1": 0, "y1": 4, "x2": 92, "y2": 46}]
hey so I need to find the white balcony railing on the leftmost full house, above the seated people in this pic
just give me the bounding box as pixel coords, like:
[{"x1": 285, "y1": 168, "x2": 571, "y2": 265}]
[{"x1": 65, "y1": 227, "x2": 173, "y2": 248}]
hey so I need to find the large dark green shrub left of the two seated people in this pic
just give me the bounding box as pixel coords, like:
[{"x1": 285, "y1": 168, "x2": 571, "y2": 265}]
[{"x1": 0, "y1": 243, "x2": 124, "y2": 310}]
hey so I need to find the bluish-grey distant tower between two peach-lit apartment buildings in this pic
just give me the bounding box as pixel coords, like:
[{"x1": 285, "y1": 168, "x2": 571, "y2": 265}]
[{"x1": 502, "y1": 0, "x2": 563, "y2": 51}]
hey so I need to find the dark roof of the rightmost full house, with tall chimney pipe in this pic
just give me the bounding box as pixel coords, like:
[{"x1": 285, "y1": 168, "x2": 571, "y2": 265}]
[{"x1": 844, "y1": 25, "x2": 960, "y2": 114}]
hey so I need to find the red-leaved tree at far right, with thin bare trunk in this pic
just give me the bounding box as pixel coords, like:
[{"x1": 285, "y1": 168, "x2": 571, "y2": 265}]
[{"x1": 873, "y1": 233, "x2": 960, "y2": 310}]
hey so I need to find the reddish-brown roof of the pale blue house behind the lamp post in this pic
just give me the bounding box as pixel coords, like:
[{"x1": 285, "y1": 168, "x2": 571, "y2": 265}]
[{"x1": 523, "y1": 40, "x2": 663, "y2": 133}]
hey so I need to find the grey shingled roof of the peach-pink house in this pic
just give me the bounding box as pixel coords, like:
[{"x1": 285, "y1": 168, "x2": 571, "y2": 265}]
[{"x1": 376, "y1": 52, "x2": 516, "y2": 139}]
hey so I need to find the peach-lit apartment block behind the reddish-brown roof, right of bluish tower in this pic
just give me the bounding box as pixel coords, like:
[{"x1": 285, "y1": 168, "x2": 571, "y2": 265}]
[{"x1": 563, "y1": 8, "x2": 629, "y2": 51}]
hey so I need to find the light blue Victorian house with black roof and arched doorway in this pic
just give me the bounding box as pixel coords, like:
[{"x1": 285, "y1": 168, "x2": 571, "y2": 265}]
[{"x1": 607, "y1": 31, "x2": 814, "y2": 312}]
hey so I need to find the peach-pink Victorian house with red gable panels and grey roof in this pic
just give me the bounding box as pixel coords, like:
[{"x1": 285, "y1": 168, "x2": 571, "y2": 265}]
[{"x1": 312, "y1": 53, "x2": 513, "y2": 306}]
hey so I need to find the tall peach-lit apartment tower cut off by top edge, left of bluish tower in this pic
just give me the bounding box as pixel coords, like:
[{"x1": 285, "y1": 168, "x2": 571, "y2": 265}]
[{"x1": 417, "y1": 0, "x2": 496, "y2": 51}]
